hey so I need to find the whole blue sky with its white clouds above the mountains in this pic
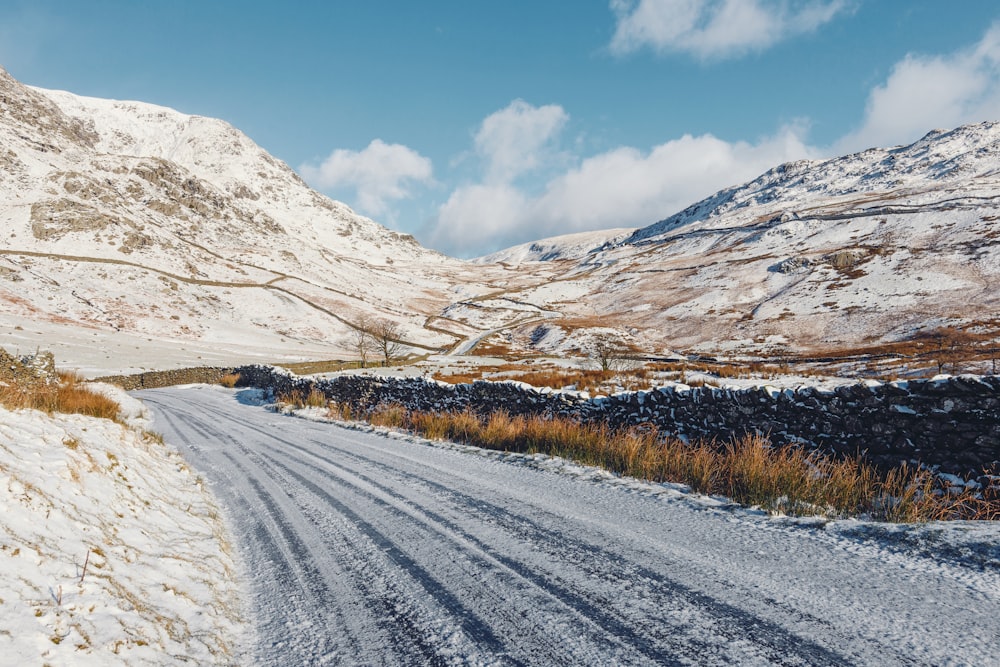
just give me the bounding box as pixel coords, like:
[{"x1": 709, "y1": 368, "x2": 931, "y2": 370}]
[{"x1": 0, "y1": 0, "x2": 1000, "y2": 256}]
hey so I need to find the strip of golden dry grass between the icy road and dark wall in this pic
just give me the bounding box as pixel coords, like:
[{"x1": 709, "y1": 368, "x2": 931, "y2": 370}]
[{"x1": 340, "y1": 405, "x2": 1000, "y2": 523}]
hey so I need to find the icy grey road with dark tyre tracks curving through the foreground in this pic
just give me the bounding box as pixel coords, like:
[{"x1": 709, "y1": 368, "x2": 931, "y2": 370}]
[{"x1": 138, "y1": 387, "x2": 1000, "y2": 665}]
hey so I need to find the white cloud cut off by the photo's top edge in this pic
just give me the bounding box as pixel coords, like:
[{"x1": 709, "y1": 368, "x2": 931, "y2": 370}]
[{"x1": 610, "y1": 0, "x2": 852, "y2": 59}]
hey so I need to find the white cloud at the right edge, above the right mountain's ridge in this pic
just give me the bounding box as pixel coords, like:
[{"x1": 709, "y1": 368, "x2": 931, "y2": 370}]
[{"x1": 834, "y1": 25, "x2": 1000, "y2": 153}]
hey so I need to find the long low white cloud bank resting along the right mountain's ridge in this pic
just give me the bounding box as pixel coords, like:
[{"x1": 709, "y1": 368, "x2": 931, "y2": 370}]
[{"x1": 427, "y1": 125, "x2": 814, "y2": 256}]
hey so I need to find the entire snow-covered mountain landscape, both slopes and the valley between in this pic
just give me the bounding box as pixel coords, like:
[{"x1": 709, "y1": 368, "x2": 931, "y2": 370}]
[{"x1": 0, "y1": 63, "x2": 1000, "y2": 372}]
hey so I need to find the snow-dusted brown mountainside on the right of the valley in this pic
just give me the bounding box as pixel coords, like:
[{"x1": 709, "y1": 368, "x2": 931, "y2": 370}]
[{"x1": 482, "y1": 122, "x2": 1000, "y2": 352}]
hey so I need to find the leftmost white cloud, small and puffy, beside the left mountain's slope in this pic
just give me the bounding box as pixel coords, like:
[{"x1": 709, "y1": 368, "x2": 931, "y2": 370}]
[{"x1": 299, "y1": 139, "x2": 434, "y2": 215}]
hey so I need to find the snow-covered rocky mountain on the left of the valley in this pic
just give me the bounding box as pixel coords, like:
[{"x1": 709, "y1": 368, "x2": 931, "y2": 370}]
[{"x1": 0, "y1": 70, "x2": 508, "y2": 376}]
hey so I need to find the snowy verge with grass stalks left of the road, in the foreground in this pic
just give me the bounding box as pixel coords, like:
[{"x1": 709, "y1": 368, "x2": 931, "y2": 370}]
[{"x1": 0, "y1": 386, "x2": 245, "y2": 667}]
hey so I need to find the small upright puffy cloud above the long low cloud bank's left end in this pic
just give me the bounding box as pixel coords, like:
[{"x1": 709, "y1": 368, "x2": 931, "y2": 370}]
[{"x1": 475, "y1": 100, "x2": 569, "y2": 183}]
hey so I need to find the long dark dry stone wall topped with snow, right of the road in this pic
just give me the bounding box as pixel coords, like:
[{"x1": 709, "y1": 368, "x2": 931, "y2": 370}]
[{"x1": 233, "y1": 366, "x2": 1000, "y2": 476}]
